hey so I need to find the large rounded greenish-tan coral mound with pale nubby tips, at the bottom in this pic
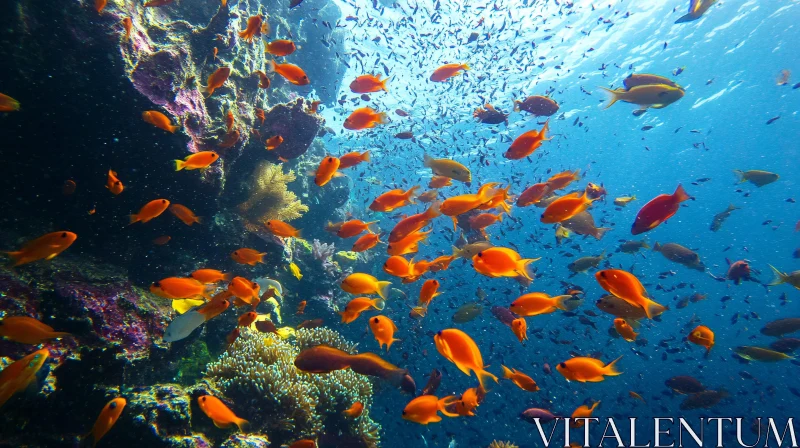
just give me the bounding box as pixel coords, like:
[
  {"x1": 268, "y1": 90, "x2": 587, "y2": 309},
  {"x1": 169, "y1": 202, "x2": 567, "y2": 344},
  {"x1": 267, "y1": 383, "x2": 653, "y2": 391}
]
[{"x1": 207, "y1": 328, "x2": 380, "y2": 447}]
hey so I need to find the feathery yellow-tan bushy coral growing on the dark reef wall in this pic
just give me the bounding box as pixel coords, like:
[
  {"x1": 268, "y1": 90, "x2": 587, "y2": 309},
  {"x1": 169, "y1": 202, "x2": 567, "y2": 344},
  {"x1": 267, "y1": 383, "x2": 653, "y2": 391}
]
[{"x1": 239, "y1": 161, "x2": 308, "y2": 229}]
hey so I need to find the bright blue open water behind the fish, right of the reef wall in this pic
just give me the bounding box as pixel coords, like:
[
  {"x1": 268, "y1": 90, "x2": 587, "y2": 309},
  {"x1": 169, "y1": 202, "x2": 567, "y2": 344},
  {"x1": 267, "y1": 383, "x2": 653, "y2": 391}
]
[{"x1": 318, "y1": 1, "x2": 800, "y2": 447}]
